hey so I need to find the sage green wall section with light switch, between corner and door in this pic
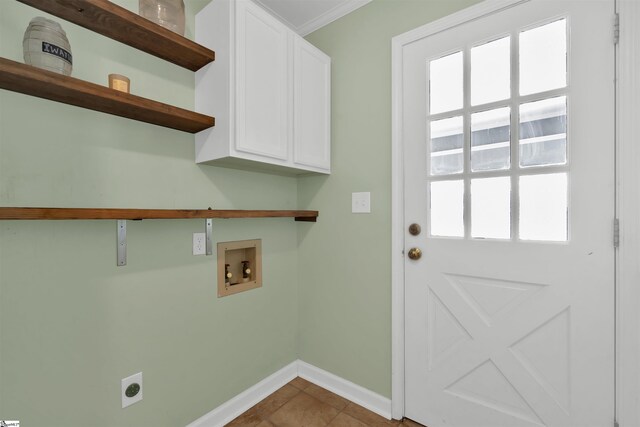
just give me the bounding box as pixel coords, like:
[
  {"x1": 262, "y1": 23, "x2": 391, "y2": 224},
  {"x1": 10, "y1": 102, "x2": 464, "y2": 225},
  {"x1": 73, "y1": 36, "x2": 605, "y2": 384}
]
[{"x1": 298, "y1": 0, "x2": 475, "y2": 397}]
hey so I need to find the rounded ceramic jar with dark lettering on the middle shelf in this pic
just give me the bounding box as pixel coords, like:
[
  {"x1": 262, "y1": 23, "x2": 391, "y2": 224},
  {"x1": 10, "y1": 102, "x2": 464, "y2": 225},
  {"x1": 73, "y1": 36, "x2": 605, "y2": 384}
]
[{"x1": 22, "y1": 17, "x2": 73, "y2": 76}]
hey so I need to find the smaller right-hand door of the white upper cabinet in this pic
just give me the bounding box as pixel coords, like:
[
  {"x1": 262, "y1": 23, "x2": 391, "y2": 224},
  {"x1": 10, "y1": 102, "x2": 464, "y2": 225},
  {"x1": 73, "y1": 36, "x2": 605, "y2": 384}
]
[{"x1": 293, "y1": 37, "x2": 331, "y2": 172}]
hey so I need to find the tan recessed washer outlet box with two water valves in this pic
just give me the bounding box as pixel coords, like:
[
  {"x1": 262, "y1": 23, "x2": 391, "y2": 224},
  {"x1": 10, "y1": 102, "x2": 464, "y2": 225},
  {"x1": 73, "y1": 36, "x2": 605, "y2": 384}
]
[{"x1": 218, "y1": 239, "x2": 262, "y2": 297}]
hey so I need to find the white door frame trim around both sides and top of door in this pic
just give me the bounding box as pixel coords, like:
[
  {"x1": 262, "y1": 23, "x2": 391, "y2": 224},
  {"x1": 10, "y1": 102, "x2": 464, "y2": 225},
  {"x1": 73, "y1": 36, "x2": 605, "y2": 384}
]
[{"x1": 391, "y1": 0, "x2": 640, "y2": 427}]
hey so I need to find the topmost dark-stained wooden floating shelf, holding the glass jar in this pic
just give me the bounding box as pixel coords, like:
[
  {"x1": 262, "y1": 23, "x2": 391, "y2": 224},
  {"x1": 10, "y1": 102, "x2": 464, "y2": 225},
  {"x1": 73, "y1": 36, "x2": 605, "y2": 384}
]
[{"x1": 18, "y1": 0, "x2": 215, "y2": 71}]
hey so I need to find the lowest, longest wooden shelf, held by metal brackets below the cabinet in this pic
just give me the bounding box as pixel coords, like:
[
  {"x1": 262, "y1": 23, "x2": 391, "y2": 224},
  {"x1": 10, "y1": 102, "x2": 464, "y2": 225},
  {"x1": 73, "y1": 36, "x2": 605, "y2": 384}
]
[{"x1": 0, "y1": 207, "x2": 318, "y2": 222}]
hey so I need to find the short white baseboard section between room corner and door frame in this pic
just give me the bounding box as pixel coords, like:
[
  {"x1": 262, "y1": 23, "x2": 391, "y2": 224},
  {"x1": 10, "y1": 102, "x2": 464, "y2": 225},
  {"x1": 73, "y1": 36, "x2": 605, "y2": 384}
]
[{"x1": 298, "y1": 360, "x2": 391, "y2": 420}]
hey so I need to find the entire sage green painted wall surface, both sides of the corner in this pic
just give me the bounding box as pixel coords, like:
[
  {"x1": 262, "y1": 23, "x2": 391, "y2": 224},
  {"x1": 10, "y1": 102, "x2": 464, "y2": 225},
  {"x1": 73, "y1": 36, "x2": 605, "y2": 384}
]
[{"x1": 0, "y1": 0, "x2": 484, "y2": 427}]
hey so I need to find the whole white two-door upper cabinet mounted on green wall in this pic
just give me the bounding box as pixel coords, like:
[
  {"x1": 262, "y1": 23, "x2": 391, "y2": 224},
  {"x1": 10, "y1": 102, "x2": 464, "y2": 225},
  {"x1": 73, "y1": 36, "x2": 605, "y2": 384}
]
[{"x1": 195, "y1": 0, "x2": 331, "y2": 174}]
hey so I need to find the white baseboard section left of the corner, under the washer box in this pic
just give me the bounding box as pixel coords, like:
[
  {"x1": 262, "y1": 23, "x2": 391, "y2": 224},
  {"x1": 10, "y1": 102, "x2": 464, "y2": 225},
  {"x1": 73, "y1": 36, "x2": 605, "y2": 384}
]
[{"x1": 187, "y1": 361, "x2": 298, "y2": 427}]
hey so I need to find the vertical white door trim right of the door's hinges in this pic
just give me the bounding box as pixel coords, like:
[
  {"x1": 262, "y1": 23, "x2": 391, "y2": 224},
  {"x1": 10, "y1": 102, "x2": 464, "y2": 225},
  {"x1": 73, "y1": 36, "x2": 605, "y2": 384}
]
[{"x1": 616, "y1": 0, "x2": 640, "y2": 427}]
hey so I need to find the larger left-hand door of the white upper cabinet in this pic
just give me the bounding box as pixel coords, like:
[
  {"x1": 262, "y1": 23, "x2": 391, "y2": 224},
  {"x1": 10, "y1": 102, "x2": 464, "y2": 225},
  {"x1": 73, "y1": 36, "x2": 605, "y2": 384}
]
[{"x1": 236, "y1": 0, "x2": 290, "y2": 161}]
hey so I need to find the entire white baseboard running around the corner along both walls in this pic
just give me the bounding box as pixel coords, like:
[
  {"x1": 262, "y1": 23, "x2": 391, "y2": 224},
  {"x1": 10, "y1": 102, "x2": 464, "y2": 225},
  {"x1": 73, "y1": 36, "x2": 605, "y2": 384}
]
[{"x1": 187, "y1": 360, "x2": 391, "y2": 427}]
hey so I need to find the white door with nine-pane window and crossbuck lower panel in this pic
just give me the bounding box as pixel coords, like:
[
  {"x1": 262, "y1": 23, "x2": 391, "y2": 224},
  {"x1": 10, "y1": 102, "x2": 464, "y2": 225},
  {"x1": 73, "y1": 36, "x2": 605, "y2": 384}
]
[{"x1": 400, "y1": 0, "x2": 614, "y2": 427}]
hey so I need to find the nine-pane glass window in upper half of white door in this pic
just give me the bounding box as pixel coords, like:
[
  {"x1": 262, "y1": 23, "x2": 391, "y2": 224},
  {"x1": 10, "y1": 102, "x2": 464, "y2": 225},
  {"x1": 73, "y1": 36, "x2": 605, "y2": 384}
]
[{"x1": 427, "y1": 19, "x2": 569, "y2": 242}]
